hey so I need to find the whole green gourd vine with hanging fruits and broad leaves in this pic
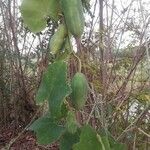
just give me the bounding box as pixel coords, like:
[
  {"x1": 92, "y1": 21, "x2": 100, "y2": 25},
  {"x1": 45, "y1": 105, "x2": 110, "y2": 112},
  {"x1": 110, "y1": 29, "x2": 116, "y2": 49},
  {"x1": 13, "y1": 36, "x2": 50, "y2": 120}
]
[{"x1": 20, "y1": 0, "x2": 126, "y2": 150}]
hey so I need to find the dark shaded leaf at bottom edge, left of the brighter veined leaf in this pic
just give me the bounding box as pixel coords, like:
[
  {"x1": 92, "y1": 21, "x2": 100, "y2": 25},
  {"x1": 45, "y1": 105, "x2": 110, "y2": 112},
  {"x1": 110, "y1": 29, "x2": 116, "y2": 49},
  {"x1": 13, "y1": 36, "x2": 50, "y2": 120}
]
[{"x1": 60, "y1": 132, "x2": 80, "y2": 150}]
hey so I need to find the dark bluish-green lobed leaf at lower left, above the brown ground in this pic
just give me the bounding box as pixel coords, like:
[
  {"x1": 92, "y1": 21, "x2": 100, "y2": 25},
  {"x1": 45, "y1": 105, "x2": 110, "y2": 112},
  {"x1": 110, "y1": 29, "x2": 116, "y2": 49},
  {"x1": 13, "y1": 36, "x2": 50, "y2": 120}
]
[{"x1": 29, "y1": 117, "x2": 64, "y2": 144}]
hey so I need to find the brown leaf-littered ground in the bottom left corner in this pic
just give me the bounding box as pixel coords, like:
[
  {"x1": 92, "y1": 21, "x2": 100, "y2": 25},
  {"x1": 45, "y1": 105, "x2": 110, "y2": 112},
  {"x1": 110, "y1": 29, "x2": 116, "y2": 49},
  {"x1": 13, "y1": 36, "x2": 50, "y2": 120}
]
[{"x1": 0, "y1": 126, "x2": 59, "y2": 150}]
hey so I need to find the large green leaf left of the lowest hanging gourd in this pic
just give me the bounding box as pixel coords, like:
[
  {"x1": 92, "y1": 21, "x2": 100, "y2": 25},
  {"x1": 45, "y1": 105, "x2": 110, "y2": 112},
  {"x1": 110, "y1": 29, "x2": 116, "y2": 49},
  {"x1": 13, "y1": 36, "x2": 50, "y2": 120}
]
[{"x1": 36, "y1": 61, "x2": 71, "y2": 118}]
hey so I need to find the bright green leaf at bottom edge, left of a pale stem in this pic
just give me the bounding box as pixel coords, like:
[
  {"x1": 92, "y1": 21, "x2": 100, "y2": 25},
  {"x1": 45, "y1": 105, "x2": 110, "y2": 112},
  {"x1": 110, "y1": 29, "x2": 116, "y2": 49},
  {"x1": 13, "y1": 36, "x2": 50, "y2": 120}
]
[{"x1": 73, "y1": 125, "x2": 104, "y2": 150}]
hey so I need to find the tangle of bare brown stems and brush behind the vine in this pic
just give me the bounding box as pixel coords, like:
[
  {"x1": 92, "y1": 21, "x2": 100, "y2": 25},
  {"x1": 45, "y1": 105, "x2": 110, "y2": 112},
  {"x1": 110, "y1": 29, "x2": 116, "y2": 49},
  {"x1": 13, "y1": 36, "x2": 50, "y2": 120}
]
[{"x1": 0, "y1": 0, "x2": 150, "y2": 150}]
